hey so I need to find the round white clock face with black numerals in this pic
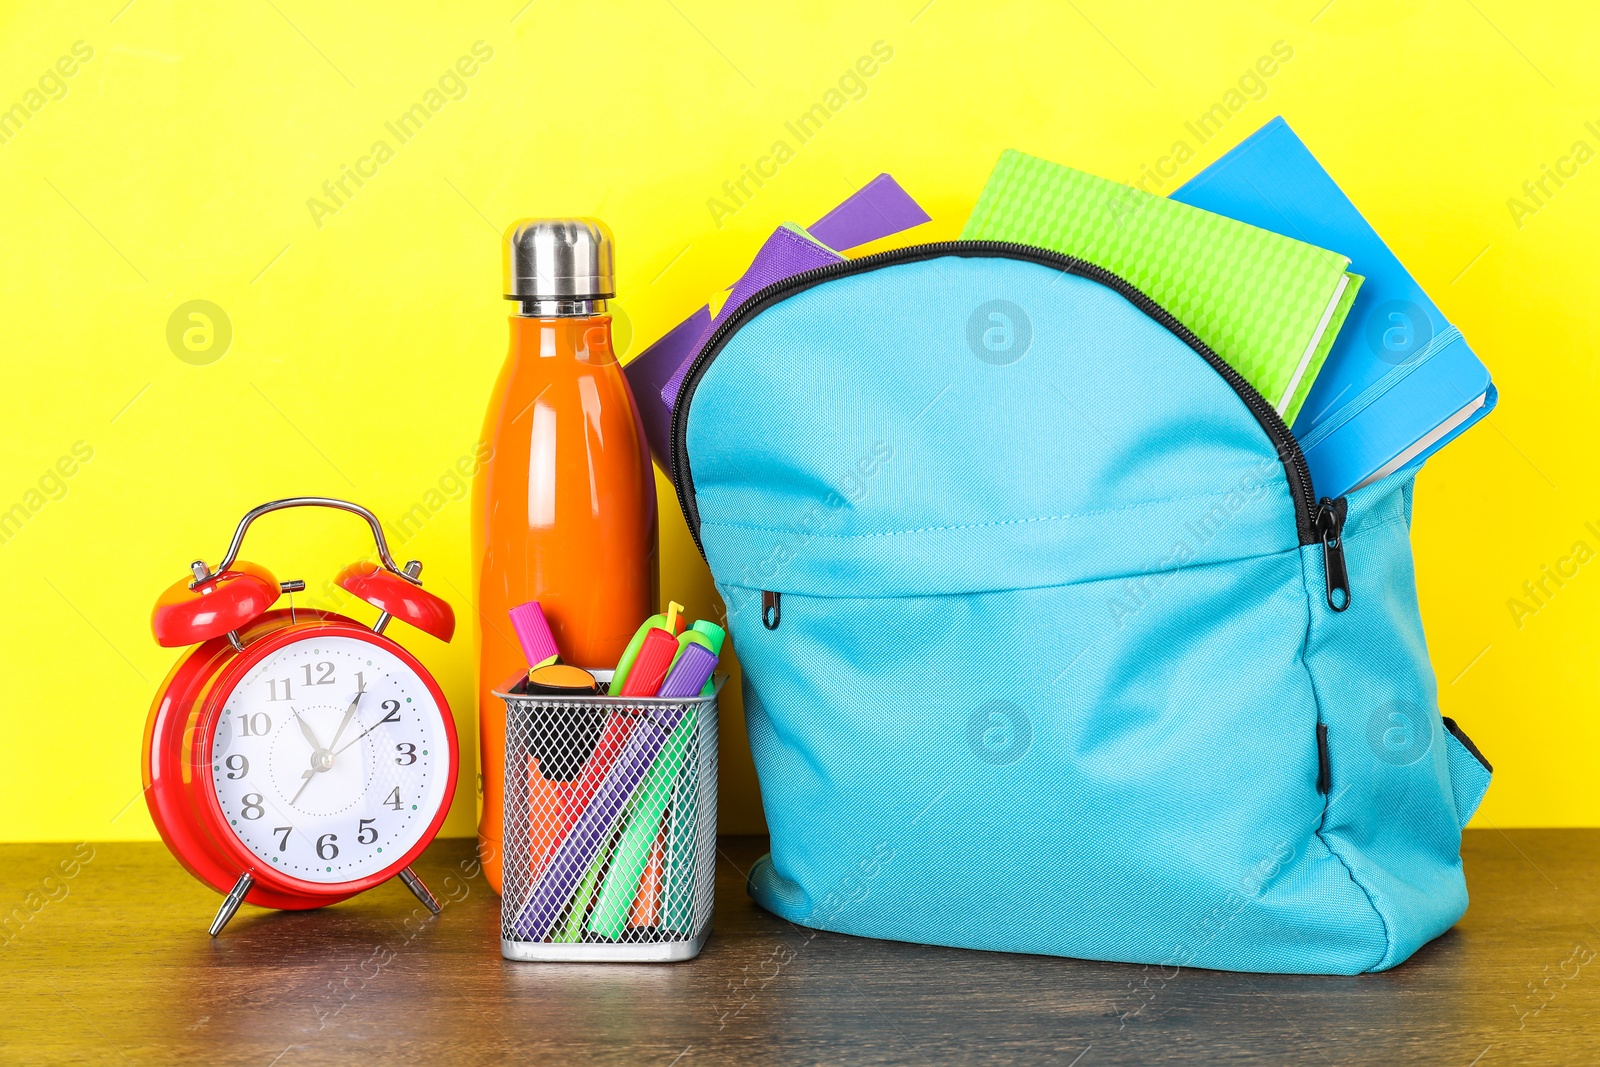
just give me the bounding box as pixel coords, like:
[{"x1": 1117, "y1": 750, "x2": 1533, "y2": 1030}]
[{"x1": 211, "y1": 635, "x2": 450, "y2": 883}]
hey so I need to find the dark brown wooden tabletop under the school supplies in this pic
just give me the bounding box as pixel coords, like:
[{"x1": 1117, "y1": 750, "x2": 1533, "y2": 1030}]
[{"x1": 0, "y1": 830, "x2": 1600, "y2": 1067}]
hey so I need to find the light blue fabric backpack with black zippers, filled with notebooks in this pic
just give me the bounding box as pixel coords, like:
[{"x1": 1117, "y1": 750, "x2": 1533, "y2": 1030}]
[{"x1": 674, "y1": 242, "x2": 1490, "y2": 974}]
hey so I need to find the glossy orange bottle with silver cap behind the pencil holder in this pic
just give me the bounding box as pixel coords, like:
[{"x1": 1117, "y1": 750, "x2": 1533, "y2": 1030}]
[{"x1": 472, "y1": 219, "x2": 658, "y2": 893}]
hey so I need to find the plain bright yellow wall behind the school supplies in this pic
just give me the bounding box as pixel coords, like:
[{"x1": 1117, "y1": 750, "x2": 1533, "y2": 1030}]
[{"x1": 0, "y1": 0, "x2": 1600, "y2": 840}]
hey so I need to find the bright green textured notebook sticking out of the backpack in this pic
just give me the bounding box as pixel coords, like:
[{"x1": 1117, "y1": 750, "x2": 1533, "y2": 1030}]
[{"x1": 962, "y1": 150, "x2": 1362, "y2": 424}]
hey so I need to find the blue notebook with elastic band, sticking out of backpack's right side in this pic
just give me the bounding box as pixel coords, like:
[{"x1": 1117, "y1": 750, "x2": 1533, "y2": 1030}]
[{"x1": 1171, "y1": 118, "x2": 1498, "y2": 496}]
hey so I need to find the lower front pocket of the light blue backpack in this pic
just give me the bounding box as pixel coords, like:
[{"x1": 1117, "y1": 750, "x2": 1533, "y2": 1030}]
[{"x1": 722, "y1": 553, "x2": 1384, "y2": 973}]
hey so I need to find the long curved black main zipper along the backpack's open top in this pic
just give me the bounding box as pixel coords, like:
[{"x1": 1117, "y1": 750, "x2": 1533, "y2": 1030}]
[{"x1": 672, "y1": 240, "x2": 1349, "y2": 563}]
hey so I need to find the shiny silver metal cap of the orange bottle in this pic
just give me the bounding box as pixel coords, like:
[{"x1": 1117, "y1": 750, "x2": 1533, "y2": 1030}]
[{"x1": 504, "y1": 219, "x2": 616, "y2": 302}]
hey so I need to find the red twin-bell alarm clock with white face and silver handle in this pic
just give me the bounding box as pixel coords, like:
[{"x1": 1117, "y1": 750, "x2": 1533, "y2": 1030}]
[{"x1": 144, "y1": 496, "x2": 458, "y2": 937}]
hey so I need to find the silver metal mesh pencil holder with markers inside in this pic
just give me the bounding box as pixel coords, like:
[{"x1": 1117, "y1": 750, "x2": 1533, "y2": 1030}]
[{"x1": 494, "y1": 670, "x2": 726, "y2": 961}]
